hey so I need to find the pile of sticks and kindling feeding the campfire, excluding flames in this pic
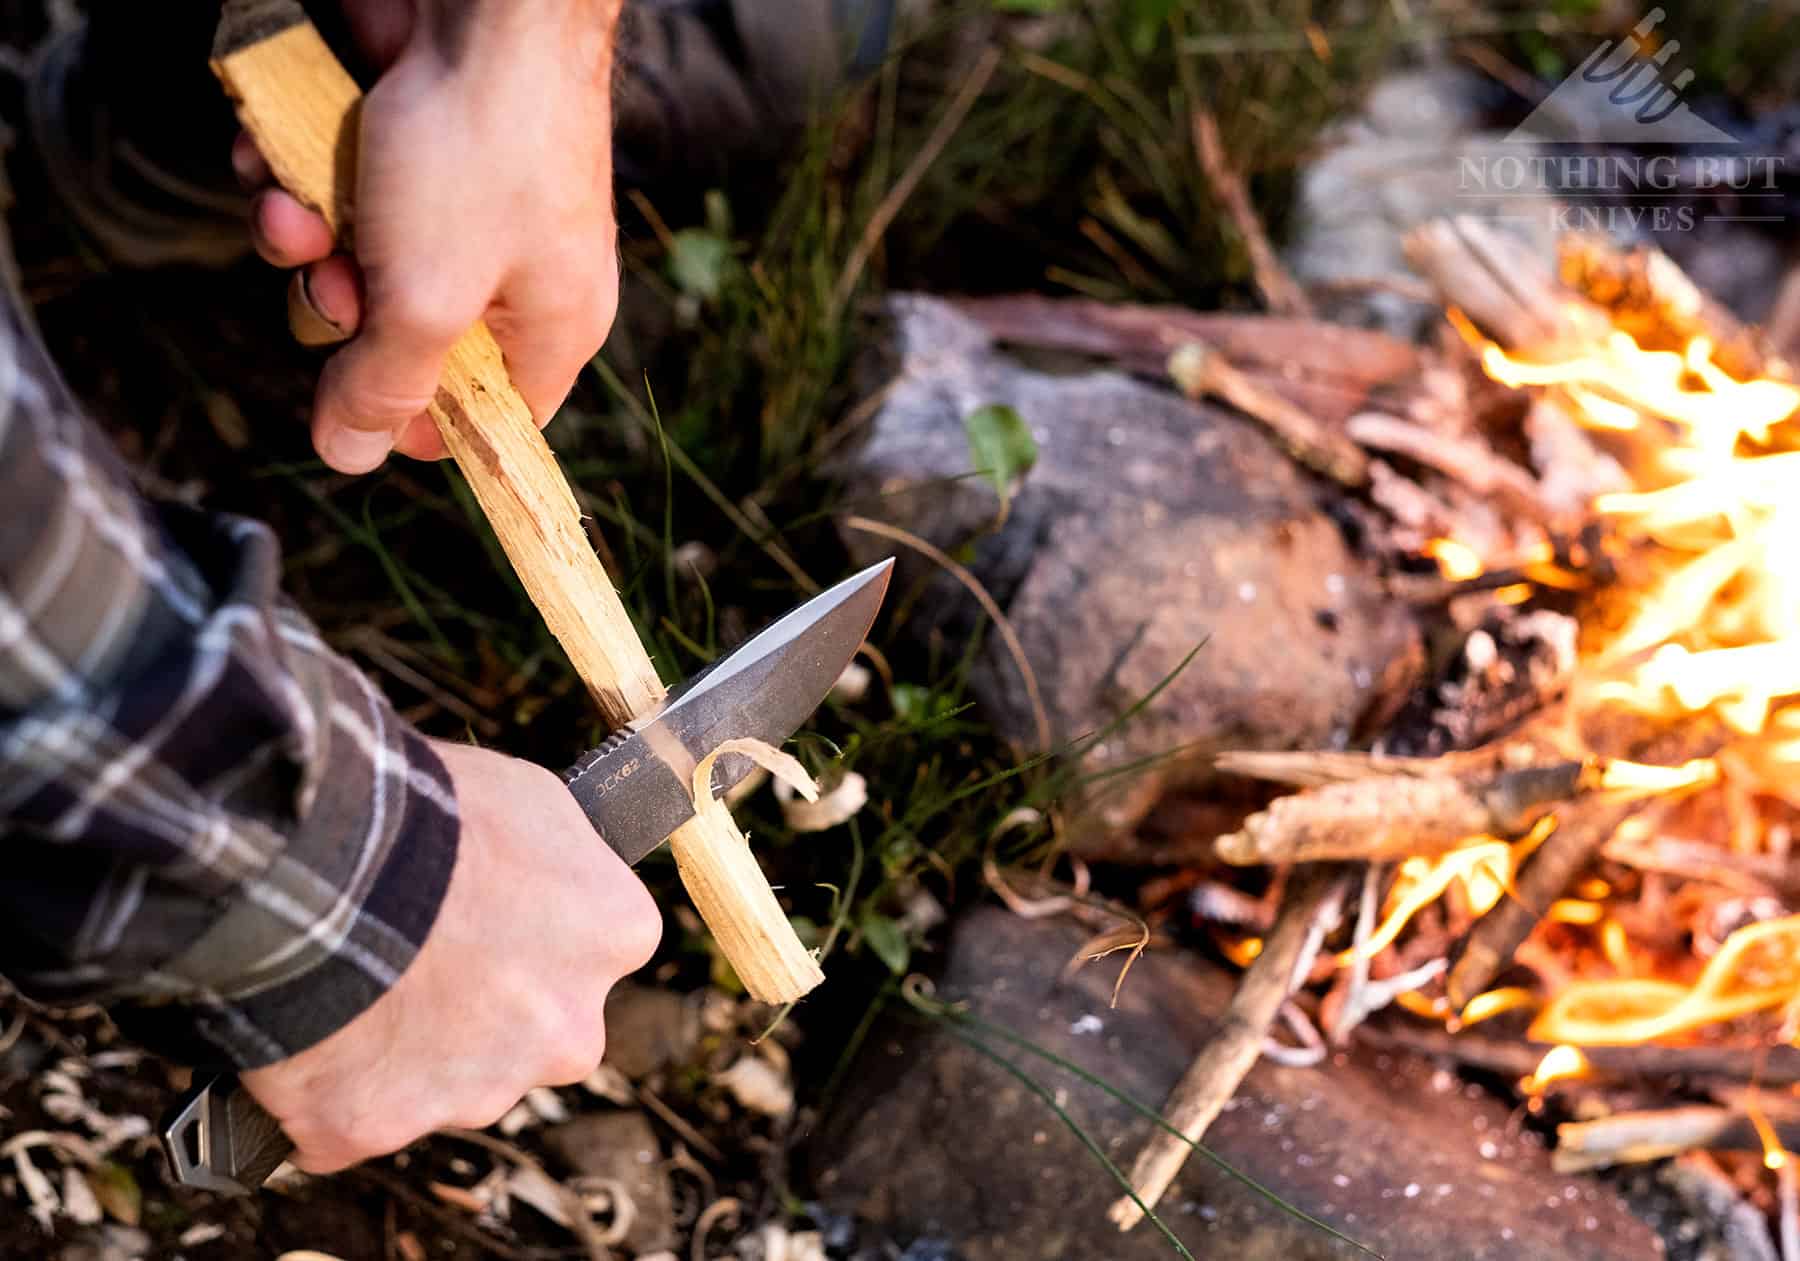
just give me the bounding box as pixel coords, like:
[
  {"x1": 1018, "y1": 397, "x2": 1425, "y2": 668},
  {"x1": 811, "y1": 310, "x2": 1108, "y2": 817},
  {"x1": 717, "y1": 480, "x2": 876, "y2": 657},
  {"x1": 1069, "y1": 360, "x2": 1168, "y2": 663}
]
[{"x1": 1111, "y1": 219, "x2": 1800, "y2": 1229}]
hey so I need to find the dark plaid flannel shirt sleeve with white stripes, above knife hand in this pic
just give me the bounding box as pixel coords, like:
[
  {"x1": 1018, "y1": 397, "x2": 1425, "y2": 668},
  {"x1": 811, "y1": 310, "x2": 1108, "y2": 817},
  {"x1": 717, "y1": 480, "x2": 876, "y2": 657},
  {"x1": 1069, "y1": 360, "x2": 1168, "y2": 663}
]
[{"x1": 0, "y1": 288, "x2": 457, "y2": 1069}]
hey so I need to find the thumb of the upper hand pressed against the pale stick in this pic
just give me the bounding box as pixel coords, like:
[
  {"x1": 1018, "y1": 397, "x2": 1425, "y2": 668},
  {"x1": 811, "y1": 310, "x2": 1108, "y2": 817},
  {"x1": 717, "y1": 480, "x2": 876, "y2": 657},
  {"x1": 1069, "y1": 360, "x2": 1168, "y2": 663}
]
[{"x1": 313, "y1": 291, "x2": 481, "y2": 473}]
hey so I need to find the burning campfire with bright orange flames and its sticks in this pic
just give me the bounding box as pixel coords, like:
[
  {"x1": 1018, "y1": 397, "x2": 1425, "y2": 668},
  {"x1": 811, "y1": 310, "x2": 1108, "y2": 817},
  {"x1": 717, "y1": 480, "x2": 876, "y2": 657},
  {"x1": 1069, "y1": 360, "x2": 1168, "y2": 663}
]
[{"x1": 1114, "y1": 221, "x2": 1800, "y2": 1230}]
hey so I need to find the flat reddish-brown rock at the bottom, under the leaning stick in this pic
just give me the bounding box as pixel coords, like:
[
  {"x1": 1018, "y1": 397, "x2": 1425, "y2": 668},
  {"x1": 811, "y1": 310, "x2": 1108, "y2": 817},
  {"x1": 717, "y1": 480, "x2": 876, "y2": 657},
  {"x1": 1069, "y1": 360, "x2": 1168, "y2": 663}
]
[{"x1": 814, "y1": 908, "x2": 1661, "y2": 1261}]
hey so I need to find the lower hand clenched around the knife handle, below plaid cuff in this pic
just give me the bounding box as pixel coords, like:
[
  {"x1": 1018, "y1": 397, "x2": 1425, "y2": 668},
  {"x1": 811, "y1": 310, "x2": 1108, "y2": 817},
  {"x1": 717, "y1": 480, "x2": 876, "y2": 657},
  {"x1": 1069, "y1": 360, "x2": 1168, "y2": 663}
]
[{"x1": 243, "y1": 743, "x2": 662, "y2": 1173}]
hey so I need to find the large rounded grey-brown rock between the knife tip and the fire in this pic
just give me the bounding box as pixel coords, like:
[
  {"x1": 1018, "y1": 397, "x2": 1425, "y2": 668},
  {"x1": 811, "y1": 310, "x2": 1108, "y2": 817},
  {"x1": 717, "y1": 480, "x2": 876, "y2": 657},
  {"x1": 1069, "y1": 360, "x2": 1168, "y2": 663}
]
[{"x1": 839, "y1": 295, "x2": 1418, "y2": 829}]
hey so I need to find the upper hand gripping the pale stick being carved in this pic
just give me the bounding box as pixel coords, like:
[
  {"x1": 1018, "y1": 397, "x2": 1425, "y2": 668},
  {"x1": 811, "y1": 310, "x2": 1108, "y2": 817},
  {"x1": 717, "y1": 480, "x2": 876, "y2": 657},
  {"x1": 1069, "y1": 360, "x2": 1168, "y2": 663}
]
[{"x1": 232, "y1": 0, "x2": 621, "y2": 473}]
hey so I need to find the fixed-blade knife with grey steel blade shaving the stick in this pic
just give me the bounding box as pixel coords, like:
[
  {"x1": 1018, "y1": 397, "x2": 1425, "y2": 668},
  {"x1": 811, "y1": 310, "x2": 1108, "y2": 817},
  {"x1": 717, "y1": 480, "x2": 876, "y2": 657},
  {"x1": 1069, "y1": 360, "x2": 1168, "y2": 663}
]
[{"x1": 160, "y1": 559, "x2": 893, "y2": 1194}]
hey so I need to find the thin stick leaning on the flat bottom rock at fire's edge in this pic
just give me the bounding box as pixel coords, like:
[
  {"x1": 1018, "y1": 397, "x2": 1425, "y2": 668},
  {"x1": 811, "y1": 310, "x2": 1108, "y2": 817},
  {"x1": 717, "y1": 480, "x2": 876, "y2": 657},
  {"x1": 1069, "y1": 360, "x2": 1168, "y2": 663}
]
[{"x1": 1107, "y1": 867, "x2": 1345, "y2": 1230}]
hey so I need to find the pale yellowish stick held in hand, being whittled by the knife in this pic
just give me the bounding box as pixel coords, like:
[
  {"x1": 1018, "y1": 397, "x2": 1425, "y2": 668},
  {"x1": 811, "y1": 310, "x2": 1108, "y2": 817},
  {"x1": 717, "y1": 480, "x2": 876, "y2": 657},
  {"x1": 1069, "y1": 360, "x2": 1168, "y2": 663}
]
[{"x1": 212, "y1": 0, "x2": 824, "y2": 1002}]
